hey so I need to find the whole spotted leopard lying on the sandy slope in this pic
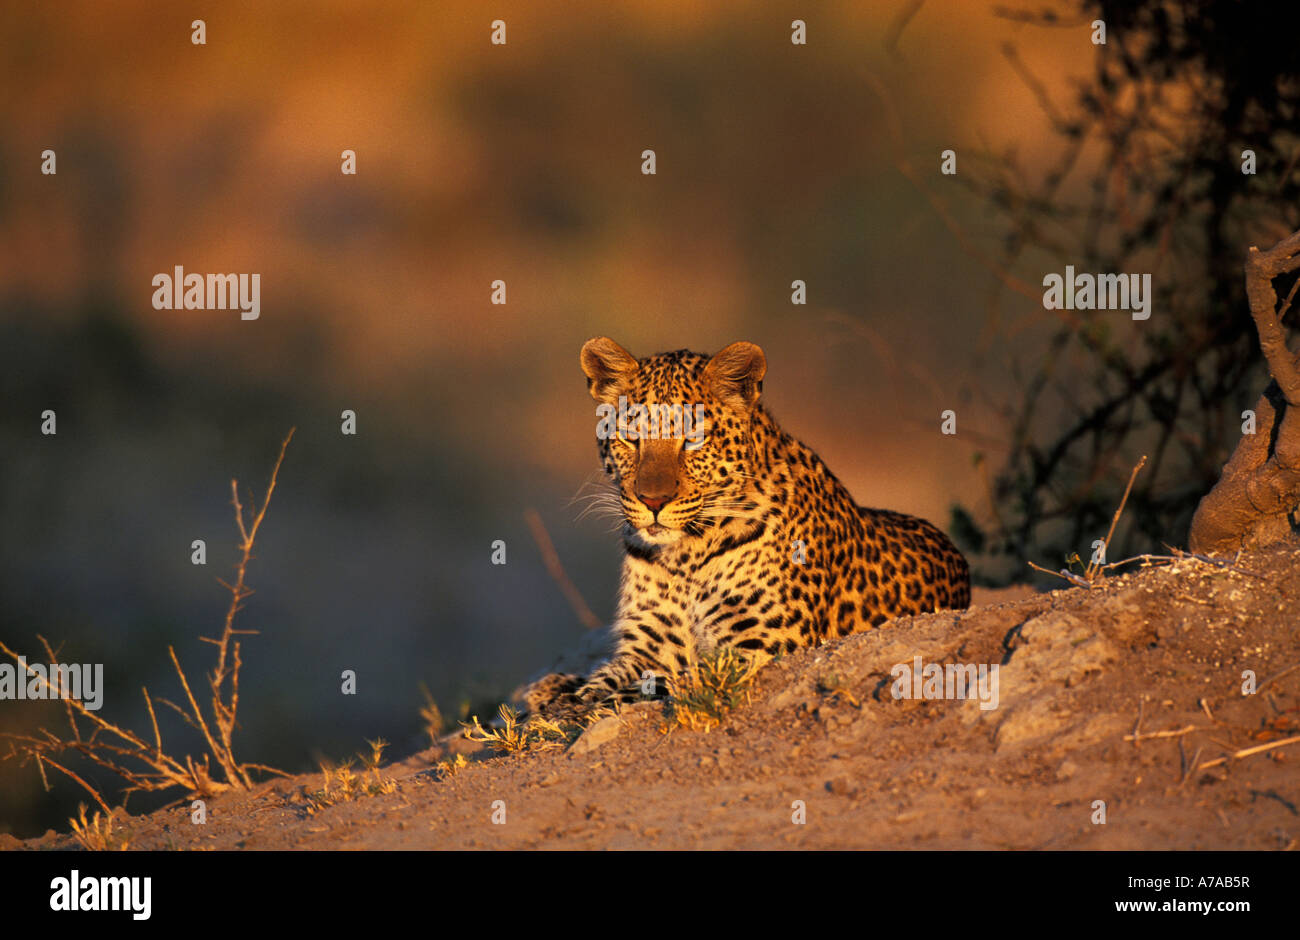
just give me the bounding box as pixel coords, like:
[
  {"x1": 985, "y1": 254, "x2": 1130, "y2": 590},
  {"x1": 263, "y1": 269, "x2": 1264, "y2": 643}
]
[{"x1": 521, "y1": 337, "x2": 971, "y2": 716}]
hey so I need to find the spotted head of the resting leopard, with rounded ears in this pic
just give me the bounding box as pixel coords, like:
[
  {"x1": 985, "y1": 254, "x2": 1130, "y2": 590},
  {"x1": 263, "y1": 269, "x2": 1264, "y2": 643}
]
[{"x1": 581, "y1": 337, "x2": 767, "y2": 547}]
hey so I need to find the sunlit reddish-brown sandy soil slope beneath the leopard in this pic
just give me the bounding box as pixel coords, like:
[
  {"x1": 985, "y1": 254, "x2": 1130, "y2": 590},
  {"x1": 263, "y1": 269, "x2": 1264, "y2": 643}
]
[{"x1": 0, "y1": 535, "x2": 1300, "y2": 849}]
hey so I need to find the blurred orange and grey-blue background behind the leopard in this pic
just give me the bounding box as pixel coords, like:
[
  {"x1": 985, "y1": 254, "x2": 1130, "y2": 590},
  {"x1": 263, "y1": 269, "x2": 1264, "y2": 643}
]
[{"x1": 0, "y1": 0, "x2": 1296, "y2": 836}]
